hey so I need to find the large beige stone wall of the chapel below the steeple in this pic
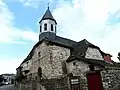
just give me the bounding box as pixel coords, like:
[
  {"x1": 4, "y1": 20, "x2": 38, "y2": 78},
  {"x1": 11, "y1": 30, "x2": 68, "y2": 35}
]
[{"x1": 30, "y1": 42, "x2": 70, "y2": 79}]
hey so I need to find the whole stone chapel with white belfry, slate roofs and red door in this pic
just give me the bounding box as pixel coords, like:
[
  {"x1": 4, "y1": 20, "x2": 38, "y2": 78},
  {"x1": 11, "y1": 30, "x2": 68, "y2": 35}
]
[{"x1": 16, "y1": 7, "x2": 120, "y2": 90}]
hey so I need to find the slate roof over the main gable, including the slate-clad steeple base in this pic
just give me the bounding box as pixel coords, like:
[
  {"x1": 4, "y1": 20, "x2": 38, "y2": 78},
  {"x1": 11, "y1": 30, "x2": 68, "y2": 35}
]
[{"x1": 21, "y1": 32, "x2": 77, "y2": 64}]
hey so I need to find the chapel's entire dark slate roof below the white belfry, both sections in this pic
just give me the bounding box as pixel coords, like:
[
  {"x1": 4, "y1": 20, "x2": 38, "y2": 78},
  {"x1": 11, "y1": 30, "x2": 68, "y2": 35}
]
[{"x1": 21, "y1": 32, "x2": 117, "y2": 66}]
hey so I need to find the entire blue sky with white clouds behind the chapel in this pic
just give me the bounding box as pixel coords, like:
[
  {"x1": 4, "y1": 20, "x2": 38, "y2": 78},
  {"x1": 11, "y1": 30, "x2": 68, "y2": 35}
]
[{"x1": 0, "y1": 0, "x2": 120, "y2": 74}]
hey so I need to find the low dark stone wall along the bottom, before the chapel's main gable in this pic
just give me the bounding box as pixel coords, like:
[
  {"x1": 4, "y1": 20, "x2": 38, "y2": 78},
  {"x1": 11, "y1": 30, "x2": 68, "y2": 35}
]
[{"x1": 17, "y1": 78, "x2": 69, "y2": 90}]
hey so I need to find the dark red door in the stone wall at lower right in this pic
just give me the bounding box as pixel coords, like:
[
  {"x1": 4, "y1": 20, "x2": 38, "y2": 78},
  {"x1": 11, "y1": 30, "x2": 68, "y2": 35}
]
[{"x1": 87, "y1": 72, "x2": 103, "y2": 90}]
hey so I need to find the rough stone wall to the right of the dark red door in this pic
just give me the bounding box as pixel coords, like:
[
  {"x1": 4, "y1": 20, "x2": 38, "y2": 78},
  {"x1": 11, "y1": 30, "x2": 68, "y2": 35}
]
[{"x1": 101, "y1": 67, "x2": 120, "y2": 90}]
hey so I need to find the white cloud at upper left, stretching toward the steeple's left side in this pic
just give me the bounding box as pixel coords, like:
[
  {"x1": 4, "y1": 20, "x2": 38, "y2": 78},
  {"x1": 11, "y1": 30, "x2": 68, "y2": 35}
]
[{"x1": 0, "y1": 1, "x2": 38, "y2": 44}]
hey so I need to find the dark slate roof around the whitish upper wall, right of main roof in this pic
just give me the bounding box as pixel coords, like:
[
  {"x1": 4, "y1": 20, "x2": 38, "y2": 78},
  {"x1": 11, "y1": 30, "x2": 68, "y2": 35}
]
[{"x1": 67, "y1": 39, "x2": 118, "y2": 67}]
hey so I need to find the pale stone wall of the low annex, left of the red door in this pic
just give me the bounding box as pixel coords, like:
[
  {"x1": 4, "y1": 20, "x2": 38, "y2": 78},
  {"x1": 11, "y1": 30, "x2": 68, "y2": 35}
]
[{"x1": 68, "y1": 60, "x2": 101, "y2": 90}]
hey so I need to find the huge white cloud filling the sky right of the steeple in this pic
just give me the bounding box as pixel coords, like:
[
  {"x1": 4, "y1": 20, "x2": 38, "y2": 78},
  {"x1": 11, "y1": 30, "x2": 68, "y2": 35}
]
[{"x1": 53, "y1": 0, "x2": 120, "y2": 61}]
